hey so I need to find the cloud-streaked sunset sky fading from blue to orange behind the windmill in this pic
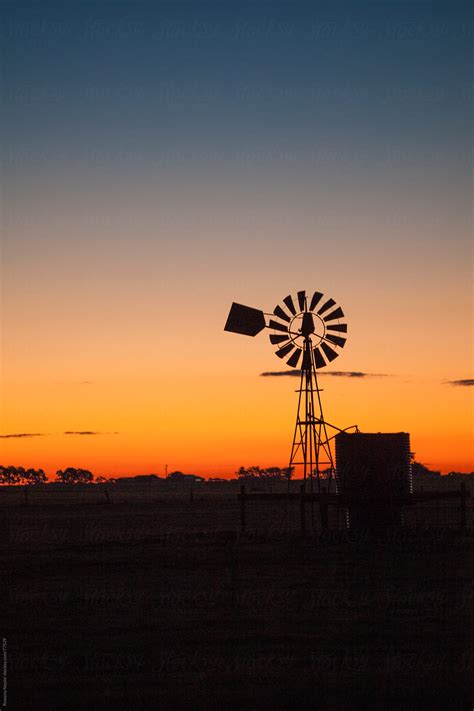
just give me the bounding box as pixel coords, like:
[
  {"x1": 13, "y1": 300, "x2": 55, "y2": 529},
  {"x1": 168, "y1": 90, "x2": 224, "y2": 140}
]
[{"x1": 0, "y1": 0, "x2": 474, "y2": 476}]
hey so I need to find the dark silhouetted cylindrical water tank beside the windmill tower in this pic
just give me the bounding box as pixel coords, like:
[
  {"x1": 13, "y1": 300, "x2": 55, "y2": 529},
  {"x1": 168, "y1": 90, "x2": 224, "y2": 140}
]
[{"x1": 336, "y1": 432, "x2": 413, "y2": 528}]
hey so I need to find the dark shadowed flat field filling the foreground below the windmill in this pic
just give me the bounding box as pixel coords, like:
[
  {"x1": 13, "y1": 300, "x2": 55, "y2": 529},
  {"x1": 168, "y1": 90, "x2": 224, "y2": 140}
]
[{"x1": 4, "y1": 494, "x2": 474, "y2": 711}]
